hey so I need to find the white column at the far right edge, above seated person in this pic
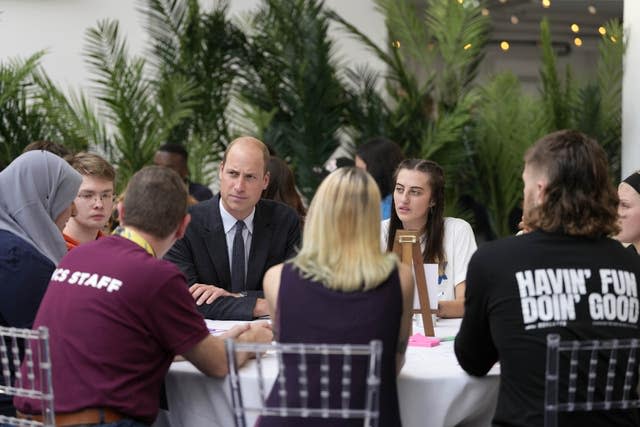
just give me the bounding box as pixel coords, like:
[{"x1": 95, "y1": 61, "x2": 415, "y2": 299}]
[{"x1": 621, "y1": 0, "x2": 640, "y2": 179}]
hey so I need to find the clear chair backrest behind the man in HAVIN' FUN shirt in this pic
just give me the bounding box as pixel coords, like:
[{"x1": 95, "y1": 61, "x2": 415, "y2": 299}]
[{"x1": 544, "y1": 334, "x2": 640, "y2": 427}]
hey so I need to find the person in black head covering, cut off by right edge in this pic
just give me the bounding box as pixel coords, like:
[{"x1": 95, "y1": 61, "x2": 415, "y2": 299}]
[{"x1": 617, "y1": 172, "x2": 640, "y2": 253}]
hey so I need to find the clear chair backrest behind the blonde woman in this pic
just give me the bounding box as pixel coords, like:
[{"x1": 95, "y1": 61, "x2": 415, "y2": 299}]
[{"x1": 226, "y1": 339, "x2": 382, "y2": 427}]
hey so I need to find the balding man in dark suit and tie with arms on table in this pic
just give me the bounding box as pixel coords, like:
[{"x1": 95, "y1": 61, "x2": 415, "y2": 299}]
[{"x1": 166, "y1": 137, "x2": 300, "y2": 320}]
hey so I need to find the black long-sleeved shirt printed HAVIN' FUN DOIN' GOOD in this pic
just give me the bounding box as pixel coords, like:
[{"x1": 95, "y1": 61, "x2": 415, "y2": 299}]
[{"x1": 455, "y1": 231, "x2": 640, "y2": 426}]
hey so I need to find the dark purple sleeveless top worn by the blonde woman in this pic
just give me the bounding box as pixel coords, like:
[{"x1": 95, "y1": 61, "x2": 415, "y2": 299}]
[{"x1": 259, "y1": 263, "x2": 402, "y2": 427}]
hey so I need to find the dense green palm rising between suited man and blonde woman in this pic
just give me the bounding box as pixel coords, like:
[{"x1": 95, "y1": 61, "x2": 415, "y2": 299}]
[{"x1": 240, "y1": 0, "x2": 347, "y2": 196}]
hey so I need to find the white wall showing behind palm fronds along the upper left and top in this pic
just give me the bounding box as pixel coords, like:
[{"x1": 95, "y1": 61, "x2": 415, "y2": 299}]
[{"x1": 0, "y1": 0, "x2": 386, "y2": 93}]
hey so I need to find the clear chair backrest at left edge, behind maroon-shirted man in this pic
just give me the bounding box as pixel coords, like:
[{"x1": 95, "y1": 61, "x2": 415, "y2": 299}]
[{"x1": 0, "y1": 326, "x2": 55, "y2": 427}]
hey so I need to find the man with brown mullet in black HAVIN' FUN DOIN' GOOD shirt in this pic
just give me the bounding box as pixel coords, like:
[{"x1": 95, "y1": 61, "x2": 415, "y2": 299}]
[{"x1": 455, "y1": 131, "x2": 640, "y2": 426}]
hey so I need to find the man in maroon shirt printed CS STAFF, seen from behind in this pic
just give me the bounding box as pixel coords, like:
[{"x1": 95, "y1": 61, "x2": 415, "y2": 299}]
[{"x1": 15, "y1": 166, "x2": 272, "y2": 427}]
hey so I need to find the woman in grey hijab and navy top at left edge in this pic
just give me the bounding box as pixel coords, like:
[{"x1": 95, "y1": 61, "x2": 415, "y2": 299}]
[{"x1": 0, "y1": 151, "x2": 82, "y2": 328}]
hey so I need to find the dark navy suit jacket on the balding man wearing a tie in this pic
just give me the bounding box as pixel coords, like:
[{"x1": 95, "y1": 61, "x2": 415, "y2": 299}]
[{"x1": 165, "y1": 195, "x2": 300, "y2": 320}]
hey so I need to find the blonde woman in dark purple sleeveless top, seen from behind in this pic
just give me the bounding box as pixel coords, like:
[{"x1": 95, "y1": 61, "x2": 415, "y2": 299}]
[{"x1": 259, "y1": 168, "x2": 413, "y2": 427}]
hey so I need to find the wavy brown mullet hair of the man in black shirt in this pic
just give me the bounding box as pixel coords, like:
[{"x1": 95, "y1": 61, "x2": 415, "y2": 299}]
[{"x1": 524, "y1": 130, "x2": 619, "y2": 238}]
